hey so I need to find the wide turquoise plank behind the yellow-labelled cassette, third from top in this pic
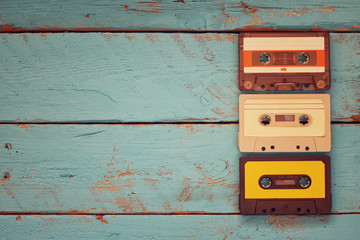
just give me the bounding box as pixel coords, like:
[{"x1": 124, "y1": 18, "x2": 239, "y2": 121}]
[{"x1": 0, "y1": 124, "x2": 360, "y2": 213}]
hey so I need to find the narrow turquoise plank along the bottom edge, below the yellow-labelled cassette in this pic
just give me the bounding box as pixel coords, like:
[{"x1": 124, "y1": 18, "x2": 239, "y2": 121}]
[{"x1": 0, "y1": 215, "x2": 360, "y2": 240}]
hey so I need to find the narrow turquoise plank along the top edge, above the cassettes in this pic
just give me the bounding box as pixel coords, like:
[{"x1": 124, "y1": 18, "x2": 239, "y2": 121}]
[{"x1": 0, "y1": 0, "x2": 360, "y2": 31}]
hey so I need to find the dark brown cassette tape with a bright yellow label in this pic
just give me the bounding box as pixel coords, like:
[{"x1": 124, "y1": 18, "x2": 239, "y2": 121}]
[{"x1": 239, "y1": 156, "x2": 331, "y2": 214}]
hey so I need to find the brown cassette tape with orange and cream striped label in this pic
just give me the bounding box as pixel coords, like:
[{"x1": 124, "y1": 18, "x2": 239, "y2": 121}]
[{"x1": 239, "y1": 32, "x2": 330, "y2": 91}]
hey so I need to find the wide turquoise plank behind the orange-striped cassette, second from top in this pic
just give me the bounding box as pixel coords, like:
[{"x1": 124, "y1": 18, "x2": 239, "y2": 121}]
[{"x1": 0, "y1": 33, "x2": 360, "y2": 122}]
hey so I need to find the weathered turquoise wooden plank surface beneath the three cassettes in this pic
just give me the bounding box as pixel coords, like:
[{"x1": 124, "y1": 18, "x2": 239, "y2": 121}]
[{"x1": 0, "y1": 0, "x2": 360, "y2": 239}]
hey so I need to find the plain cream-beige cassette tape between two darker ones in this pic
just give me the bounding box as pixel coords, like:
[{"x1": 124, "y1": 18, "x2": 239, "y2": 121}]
[{"x1": 238, "y1": 94, "x2": 331, "y2": 152}]
